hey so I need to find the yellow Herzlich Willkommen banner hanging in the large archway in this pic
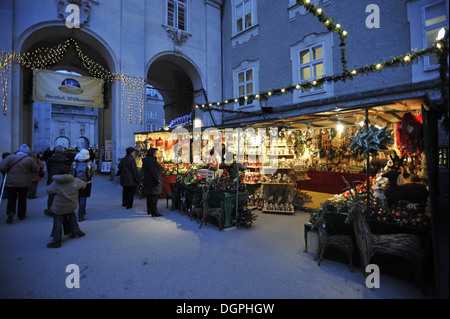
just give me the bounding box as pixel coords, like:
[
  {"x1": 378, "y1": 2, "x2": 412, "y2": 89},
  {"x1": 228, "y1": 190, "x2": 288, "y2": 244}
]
[{"x1": 33, "y1": 69, "x2": 103, "y2": 107}]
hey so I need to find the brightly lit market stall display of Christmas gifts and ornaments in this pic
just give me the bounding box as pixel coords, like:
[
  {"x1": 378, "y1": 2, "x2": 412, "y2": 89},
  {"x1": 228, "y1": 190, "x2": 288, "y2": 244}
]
[{"x1": 136, "y1": 106, "x2": 430, "y2": 231}]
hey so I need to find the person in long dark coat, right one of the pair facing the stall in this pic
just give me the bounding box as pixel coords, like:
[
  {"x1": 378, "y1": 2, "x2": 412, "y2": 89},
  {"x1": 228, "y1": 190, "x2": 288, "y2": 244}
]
[{"x1": 142, "y1": 148, "x2": 163, "y2": 217}]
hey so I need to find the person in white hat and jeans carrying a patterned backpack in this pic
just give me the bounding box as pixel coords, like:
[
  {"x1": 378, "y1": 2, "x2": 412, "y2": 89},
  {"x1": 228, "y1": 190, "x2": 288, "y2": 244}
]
[{"x1": 72, "y1": 149, "x2": 95, "y2": 222}]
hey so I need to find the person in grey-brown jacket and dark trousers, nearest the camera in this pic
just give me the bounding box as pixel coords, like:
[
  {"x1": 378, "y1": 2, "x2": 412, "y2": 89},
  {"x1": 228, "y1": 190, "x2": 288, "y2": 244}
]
[{"x1": 47, "y1": 166, "x2": 86, "y2": 248}]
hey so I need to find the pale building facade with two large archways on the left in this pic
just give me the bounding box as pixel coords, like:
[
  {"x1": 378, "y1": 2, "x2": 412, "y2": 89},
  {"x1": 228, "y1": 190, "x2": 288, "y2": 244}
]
[{"x1": 0, "y1": 0, "x2": 222, "y2": 167}]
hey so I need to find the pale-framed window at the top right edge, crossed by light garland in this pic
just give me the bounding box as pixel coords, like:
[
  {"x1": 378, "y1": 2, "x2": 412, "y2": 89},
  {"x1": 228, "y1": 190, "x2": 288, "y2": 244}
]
[{"x1": 422, "y1": 1, "x2": 447, "y2": 69}]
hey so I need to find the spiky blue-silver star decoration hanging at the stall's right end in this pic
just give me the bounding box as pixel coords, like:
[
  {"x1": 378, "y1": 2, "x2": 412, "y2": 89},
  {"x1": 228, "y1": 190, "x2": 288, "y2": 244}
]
[{"x1": 349, "y1": 126, "x2": 394, "y2": 155}]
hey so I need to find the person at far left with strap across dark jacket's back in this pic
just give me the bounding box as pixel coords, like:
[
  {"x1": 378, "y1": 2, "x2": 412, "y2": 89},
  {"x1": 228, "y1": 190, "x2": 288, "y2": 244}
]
[{"x1": 0, "y1": 144, "x2": 39, "y2": 224}]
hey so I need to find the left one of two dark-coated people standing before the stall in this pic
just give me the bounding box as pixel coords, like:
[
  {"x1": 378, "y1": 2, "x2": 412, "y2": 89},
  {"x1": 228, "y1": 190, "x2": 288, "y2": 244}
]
[{"x1": 118, "y1": 147, "x2": 139, "y2": 209}]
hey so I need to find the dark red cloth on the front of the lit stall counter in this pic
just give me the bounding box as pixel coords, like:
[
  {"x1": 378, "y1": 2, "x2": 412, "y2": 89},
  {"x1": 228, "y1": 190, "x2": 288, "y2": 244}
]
[{"x1": 297, "y1": 171, "x2": 367, "y2": 194}]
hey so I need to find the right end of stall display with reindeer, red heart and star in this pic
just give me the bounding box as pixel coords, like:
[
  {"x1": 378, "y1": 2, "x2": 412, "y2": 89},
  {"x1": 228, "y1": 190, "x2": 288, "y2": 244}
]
[{"x1": 312, "y1": 112, "x2": 430, "y2": 229}]
